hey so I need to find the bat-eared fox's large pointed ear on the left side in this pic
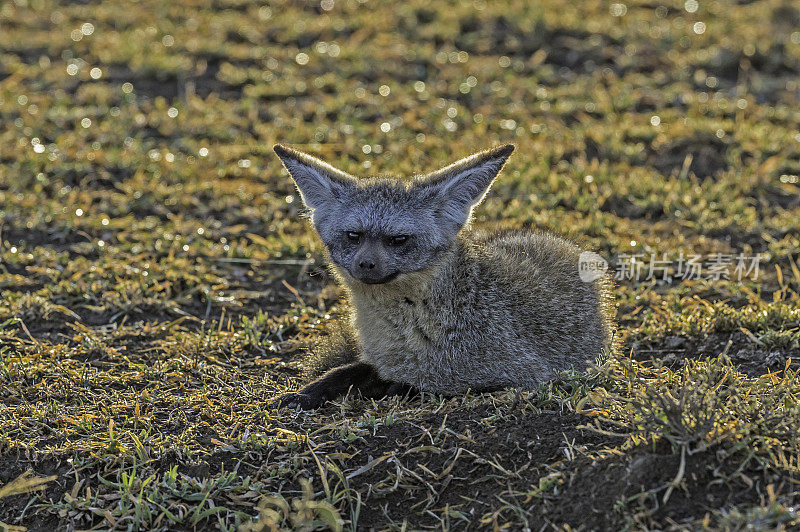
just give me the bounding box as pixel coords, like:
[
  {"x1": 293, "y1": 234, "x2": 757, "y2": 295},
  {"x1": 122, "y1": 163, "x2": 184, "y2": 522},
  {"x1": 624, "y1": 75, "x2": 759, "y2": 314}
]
[{"x1": 272, "y1": 144, "x2": 356, "y2": 209}]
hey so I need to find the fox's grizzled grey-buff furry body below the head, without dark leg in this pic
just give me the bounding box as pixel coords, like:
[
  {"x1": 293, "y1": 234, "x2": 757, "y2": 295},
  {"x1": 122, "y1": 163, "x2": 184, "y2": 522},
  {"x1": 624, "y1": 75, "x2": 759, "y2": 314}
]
[{"x1": 349, "y1": 232, "x2": 609, "y2": 394}]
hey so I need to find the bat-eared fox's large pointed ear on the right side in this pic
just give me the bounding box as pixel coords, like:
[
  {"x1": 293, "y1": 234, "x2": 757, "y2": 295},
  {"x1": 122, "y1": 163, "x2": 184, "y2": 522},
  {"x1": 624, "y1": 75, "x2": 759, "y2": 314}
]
[{"x1": 419, "y1": 144, "x2": 514, "y2": 227}]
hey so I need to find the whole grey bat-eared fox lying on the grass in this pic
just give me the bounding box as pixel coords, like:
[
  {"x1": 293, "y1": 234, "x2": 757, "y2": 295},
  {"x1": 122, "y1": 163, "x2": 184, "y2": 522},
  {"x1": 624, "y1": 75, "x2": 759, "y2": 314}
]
[{"x1": 275, "y1": 145, "x2": 613, "y2": 407}]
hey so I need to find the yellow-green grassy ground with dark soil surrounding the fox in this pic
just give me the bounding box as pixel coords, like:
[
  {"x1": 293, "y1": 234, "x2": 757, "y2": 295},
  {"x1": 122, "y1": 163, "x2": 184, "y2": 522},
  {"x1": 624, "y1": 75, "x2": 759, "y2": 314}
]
[{"x1": 0, "y1": 0, "x2": 800, "y2": 530}]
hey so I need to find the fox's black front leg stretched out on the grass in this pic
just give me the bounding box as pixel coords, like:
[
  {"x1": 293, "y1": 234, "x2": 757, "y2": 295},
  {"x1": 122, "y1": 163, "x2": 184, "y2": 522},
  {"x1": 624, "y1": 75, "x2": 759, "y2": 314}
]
[{"x1": 279, "y1": 362, "x2": 413, "y2": 410}]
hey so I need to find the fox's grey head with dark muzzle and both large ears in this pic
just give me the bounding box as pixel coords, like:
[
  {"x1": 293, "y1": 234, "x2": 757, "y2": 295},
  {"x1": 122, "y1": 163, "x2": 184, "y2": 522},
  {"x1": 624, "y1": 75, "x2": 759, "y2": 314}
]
[{"x1": 274, "y1": 145, "x2": 514, "y2": 284}]
